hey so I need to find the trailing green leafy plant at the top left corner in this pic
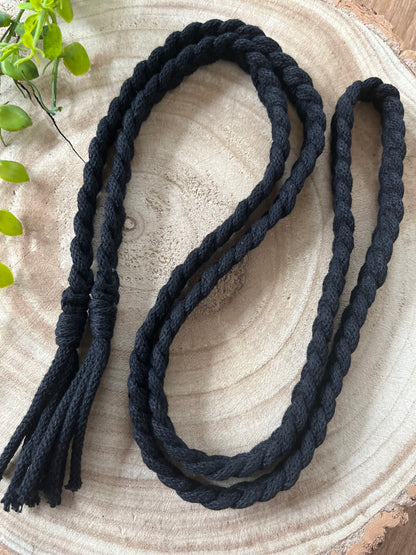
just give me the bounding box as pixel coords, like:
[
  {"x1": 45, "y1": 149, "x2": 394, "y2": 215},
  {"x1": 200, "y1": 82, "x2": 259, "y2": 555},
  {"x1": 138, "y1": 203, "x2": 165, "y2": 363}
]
[{"x1": 0, "y1": 0, "x2": 90, "y2": 288}]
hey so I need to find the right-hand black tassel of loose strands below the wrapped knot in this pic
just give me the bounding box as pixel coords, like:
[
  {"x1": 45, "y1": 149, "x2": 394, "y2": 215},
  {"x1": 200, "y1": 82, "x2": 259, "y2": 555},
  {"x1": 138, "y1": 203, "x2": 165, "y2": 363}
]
[{"x1": 1, "y1": 308, "x2": 114, "y2": 512}]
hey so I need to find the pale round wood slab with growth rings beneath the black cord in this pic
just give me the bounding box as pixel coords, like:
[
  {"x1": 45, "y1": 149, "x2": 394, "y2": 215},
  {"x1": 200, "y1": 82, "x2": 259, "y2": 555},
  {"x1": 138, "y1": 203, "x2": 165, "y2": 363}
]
[{"x1": 0, "y1": 0, "x2": 416, "y2": 555}]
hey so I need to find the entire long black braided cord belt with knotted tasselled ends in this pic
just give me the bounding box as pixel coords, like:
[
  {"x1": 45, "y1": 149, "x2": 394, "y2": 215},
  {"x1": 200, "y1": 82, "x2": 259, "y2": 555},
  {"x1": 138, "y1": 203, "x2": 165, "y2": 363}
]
[{"x1": 0, "y1": 20, "x2": 406, "y2": 511}]
